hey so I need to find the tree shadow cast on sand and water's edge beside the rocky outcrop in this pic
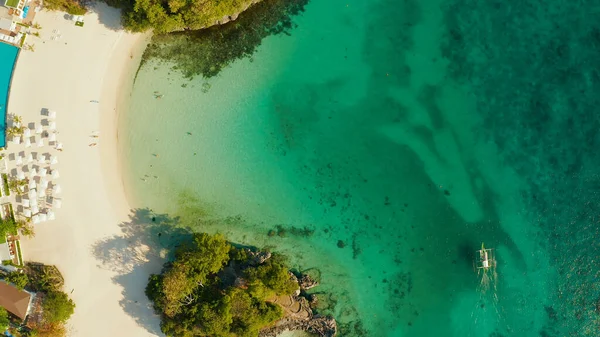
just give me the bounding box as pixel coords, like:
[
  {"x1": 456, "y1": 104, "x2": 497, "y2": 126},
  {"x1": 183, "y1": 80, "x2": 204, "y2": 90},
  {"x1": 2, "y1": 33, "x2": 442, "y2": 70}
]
[{"x1": 93, "y1": 208, "x2": 191, "y2": 336}]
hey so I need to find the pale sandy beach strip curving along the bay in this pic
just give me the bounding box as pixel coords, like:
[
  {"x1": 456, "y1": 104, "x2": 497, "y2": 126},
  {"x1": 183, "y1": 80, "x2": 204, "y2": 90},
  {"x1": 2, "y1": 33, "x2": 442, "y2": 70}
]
[{"x1": 7, "y1": 4, "x2": 160, "y2": 337}]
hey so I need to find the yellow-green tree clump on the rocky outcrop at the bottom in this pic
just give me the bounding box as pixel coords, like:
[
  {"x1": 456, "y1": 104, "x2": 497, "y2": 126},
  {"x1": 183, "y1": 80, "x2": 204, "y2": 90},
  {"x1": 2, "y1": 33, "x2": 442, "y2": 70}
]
[{"x1": 146, "y1": 233, "x2": 298, "y2": 337}]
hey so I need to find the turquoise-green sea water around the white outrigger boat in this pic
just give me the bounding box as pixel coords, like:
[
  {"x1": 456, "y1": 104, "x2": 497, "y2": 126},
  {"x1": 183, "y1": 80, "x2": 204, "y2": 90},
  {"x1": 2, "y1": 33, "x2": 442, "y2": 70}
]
[{"x1": 119, "y1": 0, "x2": 600, "y2": 337}]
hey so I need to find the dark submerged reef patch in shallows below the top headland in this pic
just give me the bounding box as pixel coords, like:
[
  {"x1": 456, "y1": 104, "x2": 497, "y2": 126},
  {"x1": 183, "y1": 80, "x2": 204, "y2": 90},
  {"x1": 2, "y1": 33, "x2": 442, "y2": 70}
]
[{"x1": 144, "y1": 0, "x2": 308, "y2": 78}]
